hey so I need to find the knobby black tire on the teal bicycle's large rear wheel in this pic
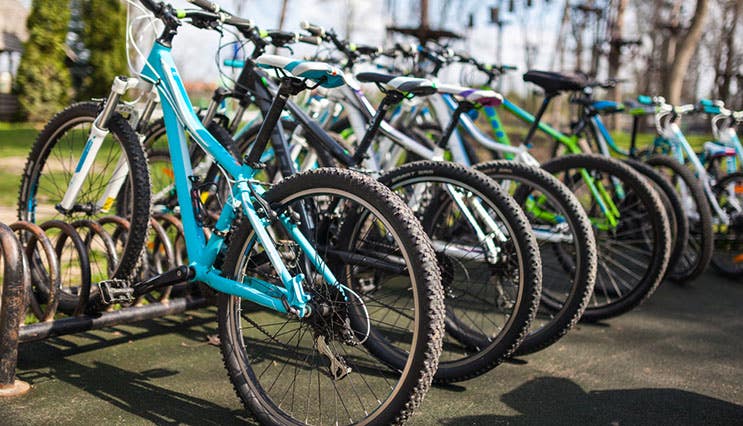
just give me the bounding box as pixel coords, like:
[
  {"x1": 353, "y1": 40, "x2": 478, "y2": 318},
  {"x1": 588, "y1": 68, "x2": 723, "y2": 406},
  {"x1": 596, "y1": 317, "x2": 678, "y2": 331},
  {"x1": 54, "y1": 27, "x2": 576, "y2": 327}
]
[{"x1": 218, "y1": 169, "x2": 444, "y2": 425}]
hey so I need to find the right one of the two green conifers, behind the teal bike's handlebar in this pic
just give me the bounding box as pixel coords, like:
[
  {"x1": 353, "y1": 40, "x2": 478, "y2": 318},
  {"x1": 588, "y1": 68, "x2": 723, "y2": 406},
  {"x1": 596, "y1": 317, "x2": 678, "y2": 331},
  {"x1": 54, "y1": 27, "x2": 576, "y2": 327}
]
[{"x1": 78, "y1": 0, "x2": 127, "y2": 99}]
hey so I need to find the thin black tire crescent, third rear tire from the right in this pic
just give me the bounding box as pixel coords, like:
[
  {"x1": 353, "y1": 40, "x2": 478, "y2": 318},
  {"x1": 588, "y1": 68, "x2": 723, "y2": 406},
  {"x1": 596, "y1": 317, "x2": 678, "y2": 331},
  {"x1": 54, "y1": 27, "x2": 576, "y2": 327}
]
[{"x1": 624, "y1": 159, "x2": 689, "y2": 278}]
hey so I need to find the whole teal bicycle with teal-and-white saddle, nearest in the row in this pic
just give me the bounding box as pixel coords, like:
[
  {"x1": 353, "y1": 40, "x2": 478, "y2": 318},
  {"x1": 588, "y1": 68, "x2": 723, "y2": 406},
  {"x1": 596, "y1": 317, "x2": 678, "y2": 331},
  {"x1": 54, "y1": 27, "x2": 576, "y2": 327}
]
[{"x1": 20, "y1": 0, "x2": 444, "y2": 425}]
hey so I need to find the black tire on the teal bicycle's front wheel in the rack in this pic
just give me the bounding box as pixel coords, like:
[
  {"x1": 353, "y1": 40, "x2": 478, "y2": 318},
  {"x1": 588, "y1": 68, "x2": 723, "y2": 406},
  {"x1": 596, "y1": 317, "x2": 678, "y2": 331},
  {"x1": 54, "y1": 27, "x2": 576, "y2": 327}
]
[{"x1": 18, "y1": 102, "x2": 150, "y2": 312}]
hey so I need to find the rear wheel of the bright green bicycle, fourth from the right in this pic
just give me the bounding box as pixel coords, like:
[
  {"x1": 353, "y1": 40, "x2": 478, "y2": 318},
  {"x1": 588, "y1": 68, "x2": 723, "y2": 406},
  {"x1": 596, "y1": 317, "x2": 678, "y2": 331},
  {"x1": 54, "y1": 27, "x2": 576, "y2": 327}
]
[{"x1": 542, "y1": 154, "x2": 671, "y2": 321}]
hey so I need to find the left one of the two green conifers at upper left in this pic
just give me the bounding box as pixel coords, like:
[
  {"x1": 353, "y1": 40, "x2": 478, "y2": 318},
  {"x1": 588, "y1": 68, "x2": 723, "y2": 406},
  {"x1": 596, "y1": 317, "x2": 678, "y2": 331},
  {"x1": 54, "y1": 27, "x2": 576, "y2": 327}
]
[{"x1": 16, "y1": 0, "x2": 72, "y2": 121}]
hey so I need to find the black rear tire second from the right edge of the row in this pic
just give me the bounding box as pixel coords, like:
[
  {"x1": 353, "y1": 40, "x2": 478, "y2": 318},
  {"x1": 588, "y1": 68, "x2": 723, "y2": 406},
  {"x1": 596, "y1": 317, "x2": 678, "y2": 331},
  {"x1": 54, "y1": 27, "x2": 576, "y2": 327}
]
[{"x1": 646, "y1": 155, "x2": 714, "y2": 283}]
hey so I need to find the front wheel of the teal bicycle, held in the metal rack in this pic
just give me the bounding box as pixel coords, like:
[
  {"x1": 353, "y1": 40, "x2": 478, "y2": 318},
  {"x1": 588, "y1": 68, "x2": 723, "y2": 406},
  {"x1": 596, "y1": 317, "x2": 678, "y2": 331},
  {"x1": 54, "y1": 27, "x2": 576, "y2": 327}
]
[{"x1": 18, "y1": 102, "x2": 150, "y2": 313}]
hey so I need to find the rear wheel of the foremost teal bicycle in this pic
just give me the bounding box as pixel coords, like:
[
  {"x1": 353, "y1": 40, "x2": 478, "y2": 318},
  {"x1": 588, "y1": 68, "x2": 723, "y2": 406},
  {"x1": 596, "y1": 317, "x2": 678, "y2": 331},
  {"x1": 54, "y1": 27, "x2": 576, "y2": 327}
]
[{"x1": 218, "y1": 169, "x2": 444, "y2": 425}]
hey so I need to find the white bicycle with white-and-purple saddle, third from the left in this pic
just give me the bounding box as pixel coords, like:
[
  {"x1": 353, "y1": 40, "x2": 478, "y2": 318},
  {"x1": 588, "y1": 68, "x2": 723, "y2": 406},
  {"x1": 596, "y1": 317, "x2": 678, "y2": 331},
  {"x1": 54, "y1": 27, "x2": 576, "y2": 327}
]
[{"x1": 286, "y1": 27, "x2": 596, "y2": 355}]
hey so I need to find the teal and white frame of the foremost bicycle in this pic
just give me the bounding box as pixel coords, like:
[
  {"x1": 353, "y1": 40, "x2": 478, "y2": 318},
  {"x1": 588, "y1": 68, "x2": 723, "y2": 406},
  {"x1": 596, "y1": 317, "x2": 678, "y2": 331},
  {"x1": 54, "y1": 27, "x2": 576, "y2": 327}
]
[{"x1": 66, "y1": 42, "x2": 350, "y2": 317}]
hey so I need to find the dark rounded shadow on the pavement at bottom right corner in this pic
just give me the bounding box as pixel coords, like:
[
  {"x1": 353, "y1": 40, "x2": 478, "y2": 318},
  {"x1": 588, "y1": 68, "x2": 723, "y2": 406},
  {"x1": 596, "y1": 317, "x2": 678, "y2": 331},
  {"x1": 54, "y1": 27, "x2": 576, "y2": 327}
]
[{"x1": 440, "y1": 377, "x2": 743, "y2": 425}]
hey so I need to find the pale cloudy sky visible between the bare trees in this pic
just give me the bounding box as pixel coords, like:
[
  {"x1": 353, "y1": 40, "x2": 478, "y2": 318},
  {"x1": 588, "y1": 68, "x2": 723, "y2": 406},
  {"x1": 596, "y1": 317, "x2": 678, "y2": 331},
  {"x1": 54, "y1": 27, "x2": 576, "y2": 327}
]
[{"x1": 131, "y1": 0, "x2": 562, "y2": 93}]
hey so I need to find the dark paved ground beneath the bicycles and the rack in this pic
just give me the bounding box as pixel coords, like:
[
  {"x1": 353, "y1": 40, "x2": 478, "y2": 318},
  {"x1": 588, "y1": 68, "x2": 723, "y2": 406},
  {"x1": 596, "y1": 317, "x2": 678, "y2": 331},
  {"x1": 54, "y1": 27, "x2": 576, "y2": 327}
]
[{"x1": 0, "y1": 274, "x2": 743, "y2": 425}]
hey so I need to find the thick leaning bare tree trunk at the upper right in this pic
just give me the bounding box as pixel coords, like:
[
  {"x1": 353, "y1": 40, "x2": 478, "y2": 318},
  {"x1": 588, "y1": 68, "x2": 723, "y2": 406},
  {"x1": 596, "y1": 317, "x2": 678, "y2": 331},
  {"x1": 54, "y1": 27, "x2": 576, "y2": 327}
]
[{"x1": 666, "y1": 0, "x2": 709, "y2": 104}]
